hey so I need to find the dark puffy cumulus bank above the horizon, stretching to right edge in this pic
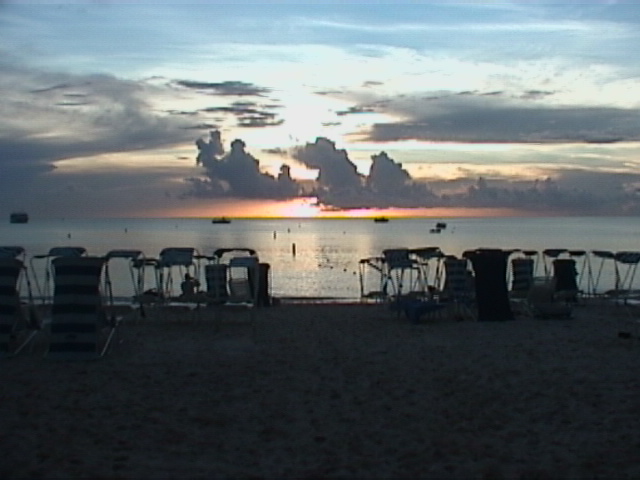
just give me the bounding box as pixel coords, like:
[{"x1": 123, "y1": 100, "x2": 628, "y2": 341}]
[{"x1": 190, "y1": 132, "x2": 640, "y2": 215}]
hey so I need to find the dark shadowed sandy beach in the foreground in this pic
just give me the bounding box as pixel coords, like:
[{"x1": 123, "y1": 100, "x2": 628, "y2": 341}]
[{"x1": 0, "y1": 304, "x2": 640, "y2": 479}]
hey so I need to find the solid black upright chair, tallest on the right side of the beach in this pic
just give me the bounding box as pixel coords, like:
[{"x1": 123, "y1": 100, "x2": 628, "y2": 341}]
[{"x1": 466, "y1": 249, "x2": 513, "y2": 322}]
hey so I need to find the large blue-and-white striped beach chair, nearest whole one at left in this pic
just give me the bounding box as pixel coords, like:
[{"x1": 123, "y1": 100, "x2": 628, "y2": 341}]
[{"x1": 46, "y1": 256, "x2": 118, "y2": 360}]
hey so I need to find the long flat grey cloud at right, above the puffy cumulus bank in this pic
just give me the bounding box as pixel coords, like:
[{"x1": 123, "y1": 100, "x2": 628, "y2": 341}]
[{"x1": 360, "y1": 91, "x2": 640, "y2": 144}]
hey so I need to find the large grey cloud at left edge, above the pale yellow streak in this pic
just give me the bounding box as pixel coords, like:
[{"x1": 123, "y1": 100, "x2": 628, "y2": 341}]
[{"x1": 0, "y1": 66, "x2": 195, "y2": 165}]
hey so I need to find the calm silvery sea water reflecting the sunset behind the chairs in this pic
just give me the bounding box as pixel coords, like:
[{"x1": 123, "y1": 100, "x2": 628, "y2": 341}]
[{"x1": 0, "y1": 217, "x2": 640, "y2": 299}]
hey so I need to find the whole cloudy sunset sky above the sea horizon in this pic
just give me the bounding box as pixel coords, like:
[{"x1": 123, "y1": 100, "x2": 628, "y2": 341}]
[{"x1": 0, "y1": 0, "x2": 640, "y2": 218}]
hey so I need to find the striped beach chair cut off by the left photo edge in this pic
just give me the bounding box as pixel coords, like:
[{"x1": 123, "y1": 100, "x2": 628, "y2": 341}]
[{"x1": 0, "y1": 251, "x2": 42, "y2": 357}]
